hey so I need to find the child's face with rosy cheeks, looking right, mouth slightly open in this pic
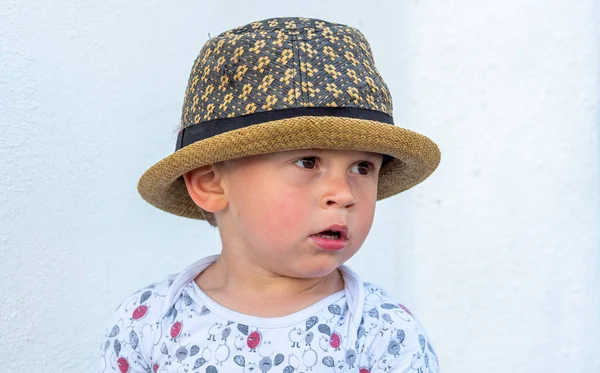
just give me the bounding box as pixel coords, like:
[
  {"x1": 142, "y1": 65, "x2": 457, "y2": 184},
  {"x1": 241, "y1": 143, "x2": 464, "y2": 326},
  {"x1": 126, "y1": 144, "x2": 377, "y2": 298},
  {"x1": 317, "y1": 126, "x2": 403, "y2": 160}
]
[{"x1": 211, "y1": 150, "x2": 382, "y2": 278}]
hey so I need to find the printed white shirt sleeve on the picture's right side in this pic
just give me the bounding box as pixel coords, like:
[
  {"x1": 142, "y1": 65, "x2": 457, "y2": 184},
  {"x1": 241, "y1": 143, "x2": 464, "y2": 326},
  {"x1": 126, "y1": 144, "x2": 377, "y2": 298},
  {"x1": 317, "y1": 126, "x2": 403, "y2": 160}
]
[{"x1": 369, "y1": 303, "x2": 440, "y2": 373}]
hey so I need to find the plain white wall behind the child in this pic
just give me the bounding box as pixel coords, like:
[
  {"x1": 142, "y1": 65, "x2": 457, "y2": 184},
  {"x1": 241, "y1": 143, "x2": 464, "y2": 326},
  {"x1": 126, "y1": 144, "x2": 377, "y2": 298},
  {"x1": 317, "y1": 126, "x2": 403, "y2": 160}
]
[{"x1": 0, "y1": 0, "x2": 600, "y2": 373}]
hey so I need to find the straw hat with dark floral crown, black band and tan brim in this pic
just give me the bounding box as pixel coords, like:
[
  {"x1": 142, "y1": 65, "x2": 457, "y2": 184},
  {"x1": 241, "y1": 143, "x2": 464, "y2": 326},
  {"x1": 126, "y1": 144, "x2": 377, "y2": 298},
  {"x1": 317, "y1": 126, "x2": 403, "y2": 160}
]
[{"x1": 138, "y1": 18, "x2": 440, "y2": 219}]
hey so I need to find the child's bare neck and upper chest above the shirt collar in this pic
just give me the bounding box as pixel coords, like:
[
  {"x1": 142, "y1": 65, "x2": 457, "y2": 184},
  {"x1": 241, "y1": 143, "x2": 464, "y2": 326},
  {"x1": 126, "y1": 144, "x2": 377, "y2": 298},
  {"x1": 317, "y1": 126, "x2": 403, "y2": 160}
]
[{"x1": 195, "y1": 253, "x2": 344, "y2": 317}]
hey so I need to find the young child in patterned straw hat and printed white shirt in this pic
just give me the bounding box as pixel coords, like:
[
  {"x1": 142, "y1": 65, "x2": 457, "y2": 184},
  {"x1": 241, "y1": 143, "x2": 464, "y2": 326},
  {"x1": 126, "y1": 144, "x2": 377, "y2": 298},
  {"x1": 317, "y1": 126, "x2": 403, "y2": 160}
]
[{"x1": 101, "y1": 18, "x2": 440, "y2": 373}]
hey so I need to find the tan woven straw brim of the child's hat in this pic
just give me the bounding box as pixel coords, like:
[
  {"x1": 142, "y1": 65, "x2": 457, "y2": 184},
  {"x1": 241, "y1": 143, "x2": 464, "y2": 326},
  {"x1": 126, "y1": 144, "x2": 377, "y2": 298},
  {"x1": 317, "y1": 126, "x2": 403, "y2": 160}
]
[{"x1": 138, "y1": 116, "x2": 440, "y2": 219}]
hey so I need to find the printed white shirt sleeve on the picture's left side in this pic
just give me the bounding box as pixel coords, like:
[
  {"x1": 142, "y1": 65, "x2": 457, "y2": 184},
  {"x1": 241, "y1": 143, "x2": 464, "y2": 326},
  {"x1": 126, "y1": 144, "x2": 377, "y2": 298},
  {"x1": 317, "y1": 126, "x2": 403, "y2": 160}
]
[{"x1": 99, "y1": 288, "x2": 160, "y2": 373}]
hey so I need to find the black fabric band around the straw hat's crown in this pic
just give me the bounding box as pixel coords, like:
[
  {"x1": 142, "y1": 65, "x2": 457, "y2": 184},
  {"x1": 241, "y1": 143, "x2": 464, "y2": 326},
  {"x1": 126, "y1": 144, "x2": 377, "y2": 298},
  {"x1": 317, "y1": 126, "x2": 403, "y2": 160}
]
[{"x1": 175, "y1": 107, "x2": 394, "y2": 151}]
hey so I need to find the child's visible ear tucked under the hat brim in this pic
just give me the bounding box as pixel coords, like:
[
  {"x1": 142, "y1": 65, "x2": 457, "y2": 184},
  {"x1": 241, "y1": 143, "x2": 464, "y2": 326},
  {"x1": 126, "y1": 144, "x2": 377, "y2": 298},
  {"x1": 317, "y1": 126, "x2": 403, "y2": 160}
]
[{"x1": 183, "y1": 165, "x2": 227, "y2": 213}]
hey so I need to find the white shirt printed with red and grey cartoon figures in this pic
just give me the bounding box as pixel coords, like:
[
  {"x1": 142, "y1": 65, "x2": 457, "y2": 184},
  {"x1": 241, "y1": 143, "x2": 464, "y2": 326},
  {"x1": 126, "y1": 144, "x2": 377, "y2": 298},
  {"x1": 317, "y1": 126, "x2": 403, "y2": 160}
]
[{"x1": 100, "y1": 256, "x2": 439, "y2": 373}]
